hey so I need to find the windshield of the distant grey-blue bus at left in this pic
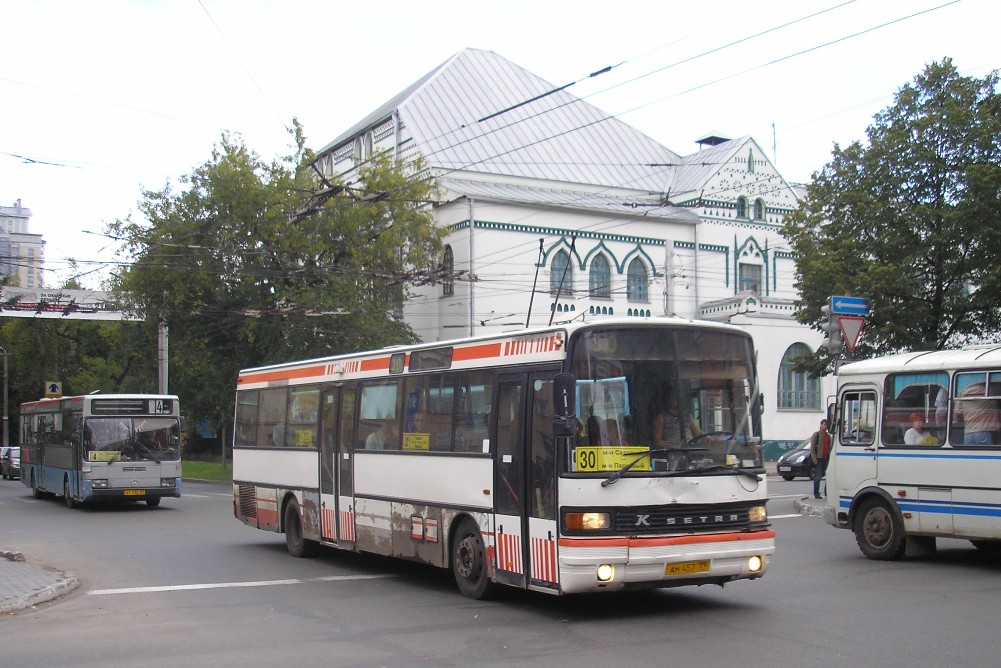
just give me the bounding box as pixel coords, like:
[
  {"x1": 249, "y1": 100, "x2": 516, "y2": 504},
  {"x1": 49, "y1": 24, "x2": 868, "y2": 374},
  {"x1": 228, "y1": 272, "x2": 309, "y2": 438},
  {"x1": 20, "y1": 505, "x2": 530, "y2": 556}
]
[{"x1": 84, "y1": 418, "x2": 180, "y2": 462}]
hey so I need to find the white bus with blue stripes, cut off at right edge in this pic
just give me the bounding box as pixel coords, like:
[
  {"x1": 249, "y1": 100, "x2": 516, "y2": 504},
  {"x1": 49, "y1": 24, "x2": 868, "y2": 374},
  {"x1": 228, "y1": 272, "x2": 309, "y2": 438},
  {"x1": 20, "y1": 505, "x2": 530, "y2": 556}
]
[{"x1": 825, "y1": 347, "x2": 1001, "y2": 560}]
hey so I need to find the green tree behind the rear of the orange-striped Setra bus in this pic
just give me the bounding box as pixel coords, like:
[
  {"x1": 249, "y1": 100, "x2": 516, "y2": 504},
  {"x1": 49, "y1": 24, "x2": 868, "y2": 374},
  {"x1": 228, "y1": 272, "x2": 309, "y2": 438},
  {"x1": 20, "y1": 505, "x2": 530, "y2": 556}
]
[{"x1": 108, "y1": 123, "x2": 441, "y2": 440}]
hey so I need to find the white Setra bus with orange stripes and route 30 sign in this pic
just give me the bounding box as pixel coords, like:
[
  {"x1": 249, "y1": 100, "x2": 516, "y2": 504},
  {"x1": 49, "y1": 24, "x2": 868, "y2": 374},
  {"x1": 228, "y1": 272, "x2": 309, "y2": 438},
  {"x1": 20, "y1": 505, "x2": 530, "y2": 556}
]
[{"x1": 233, "y1": 318, "x2": 775, "y2": 598}]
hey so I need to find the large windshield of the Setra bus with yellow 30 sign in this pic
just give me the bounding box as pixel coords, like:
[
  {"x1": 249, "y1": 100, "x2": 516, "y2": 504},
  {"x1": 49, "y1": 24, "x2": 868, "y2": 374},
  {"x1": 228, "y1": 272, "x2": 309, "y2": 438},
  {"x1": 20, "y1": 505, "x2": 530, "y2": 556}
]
[{"x1": 565, "y1": 327, "x2": 762, "y2": 473}]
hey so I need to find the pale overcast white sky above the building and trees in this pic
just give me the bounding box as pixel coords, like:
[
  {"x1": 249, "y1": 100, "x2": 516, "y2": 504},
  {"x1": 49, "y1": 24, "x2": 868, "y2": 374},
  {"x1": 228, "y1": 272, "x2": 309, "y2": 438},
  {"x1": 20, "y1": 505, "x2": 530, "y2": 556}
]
[{"x1": 0, "y1": 0, "x2": 1001, "y2": 288}]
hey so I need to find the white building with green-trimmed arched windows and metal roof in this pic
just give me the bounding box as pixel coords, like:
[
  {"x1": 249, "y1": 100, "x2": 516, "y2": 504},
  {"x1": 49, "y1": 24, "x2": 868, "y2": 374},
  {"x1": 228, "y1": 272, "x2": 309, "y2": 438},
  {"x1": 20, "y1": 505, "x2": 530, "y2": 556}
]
[{"x1": 316, "y1": 49, "x2": 833, "y2": 459}]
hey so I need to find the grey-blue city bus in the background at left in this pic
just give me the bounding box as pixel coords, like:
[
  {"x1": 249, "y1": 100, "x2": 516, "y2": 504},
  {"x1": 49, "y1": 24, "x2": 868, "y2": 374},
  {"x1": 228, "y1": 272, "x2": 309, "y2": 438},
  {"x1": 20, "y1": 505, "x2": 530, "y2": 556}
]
[{"x1": 19, "y1": 395, "x2": 181, "y2": 508}]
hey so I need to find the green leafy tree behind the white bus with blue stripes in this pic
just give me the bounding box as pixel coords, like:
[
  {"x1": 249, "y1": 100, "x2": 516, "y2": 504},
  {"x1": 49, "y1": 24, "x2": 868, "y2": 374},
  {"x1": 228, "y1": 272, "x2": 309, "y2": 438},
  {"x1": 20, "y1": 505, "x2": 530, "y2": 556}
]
[{"x1": 783, "y1": 59, "x2": 1001, "y2": 371}]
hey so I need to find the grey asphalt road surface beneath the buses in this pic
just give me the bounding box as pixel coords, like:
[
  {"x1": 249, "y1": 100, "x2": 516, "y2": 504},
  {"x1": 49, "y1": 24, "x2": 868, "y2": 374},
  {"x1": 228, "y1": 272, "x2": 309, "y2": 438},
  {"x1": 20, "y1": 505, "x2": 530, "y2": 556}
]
[{"x1": 0, "y1": 479, "x2": 1001, "y2": 668}]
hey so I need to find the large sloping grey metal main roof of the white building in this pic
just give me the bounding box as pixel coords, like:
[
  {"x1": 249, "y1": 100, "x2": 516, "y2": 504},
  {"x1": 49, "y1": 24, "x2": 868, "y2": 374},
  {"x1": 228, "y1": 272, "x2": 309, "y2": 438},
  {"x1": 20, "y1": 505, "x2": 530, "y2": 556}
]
[{"x1": 320, "y1": 49, "x2": 681, "y2": 192}]
